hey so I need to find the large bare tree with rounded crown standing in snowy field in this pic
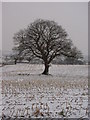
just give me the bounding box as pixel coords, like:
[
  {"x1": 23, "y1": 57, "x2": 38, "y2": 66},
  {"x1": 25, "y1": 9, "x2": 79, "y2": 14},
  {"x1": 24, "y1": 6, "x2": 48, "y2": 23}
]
[{"x1": 14, "y1": 19, "x2": 83, "y2": 75}]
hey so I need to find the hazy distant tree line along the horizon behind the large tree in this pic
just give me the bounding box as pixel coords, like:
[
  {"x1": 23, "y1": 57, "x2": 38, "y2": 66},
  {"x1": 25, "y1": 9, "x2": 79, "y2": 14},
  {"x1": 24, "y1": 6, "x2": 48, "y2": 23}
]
[{"x1": 2, "y1": 52, "x2": 86, "y2": 65}]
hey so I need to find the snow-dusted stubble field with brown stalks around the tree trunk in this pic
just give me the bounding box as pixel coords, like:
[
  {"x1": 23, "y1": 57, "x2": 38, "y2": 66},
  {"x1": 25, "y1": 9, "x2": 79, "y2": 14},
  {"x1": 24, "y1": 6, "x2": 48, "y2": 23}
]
[{"x1": 2, "y1": 64, "x2": 88, "y2": 118}]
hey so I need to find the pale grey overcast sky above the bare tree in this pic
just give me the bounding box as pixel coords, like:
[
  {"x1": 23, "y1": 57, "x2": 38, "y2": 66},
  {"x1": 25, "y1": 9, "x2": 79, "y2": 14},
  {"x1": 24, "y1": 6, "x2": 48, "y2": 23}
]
[{"x1": 2, "y1": 2, "x2": 88, "y2": 55}]
